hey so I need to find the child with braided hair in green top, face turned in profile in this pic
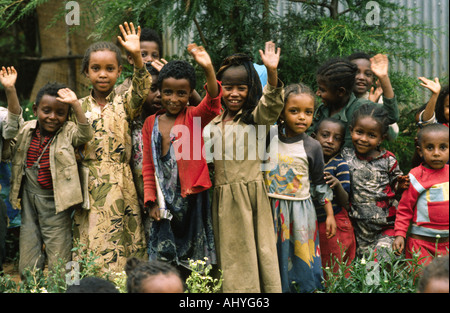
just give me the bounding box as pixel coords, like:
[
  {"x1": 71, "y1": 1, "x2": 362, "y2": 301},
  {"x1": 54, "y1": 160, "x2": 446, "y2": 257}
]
[{"x1": 308, "y1": 58, "x2": 399, "y2": 147}]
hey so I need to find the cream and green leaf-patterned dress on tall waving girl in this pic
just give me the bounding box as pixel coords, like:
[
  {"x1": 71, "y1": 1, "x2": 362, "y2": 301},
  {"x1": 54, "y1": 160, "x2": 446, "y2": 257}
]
[{"x1": 74, "y1": 68, "x2": 151, "y2": 272}]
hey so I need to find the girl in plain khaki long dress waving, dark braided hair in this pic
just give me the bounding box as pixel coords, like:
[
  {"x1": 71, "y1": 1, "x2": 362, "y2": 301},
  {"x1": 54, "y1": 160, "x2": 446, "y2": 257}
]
[{"x1": 210, "y1": 42, "x2": 283, "y2": 292}]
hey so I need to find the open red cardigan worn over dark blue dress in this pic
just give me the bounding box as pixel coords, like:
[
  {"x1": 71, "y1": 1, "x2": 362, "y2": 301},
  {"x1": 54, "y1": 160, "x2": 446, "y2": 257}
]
[{"x1": 142, "y1": 83, "x2": 222, "y2": 203}]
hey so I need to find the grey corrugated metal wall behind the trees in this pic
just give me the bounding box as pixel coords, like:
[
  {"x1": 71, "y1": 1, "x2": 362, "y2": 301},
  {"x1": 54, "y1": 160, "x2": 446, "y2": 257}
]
[{"x1": 163, "y1": 0, "x2": 449, "y2": 78}]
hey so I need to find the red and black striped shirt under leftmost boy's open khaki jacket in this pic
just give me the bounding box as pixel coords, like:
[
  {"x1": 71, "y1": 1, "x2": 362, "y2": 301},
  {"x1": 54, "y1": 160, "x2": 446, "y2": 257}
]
[{"x1": 27, "y1": 128, "x2": 53, "y2": 189}]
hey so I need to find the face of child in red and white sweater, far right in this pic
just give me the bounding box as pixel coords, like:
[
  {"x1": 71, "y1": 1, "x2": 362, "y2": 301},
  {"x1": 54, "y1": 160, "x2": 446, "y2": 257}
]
[{"x1": 418, "y1": 131, "x2": 449, "y2": 169}]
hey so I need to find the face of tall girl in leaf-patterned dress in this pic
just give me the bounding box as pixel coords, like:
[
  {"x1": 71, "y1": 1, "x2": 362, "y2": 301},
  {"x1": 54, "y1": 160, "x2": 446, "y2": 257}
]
[{"x1": 86, "y1": 50, "x2": 122, "y2": 95}]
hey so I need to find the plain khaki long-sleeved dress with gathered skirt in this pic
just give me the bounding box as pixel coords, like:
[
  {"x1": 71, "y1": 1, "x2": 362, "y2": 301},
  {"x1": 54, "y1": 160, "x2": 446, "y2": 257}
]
[{"x1": 207, "y1": 82, "x2": 284, "y2": 293}]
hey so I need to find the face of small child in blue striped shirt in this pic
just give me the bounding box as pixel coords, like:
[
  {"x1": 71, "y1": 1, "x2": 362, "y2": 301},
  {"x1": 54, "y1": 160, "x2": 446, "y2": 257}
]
[{"x1": 316, "y1": 121, "x2": 345, "y2": 160}]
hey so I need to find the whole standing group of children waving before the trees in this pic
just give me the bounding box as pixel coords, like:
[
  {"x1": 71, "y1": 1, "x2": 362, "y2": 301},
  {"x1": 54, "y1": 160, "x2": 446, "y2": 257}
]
[{"x1": 0, "y1": 23, "x2": 449, "y2": 292}]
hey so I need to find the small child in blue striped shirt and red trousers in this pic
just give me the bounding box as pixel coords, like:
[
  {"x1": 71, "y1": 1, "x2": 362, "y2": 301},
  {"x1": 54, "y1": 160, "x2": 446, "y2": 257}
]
[{"x1": 313, "y1": 118, "x2": 356, "y2": 271}]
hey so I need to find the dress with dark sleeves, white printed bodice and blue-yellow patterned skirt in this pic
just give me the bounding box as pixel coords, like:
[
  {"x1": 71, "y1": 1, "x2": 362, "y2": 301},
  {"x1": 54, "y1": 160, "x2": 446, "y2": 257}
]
[{"x1": 265, "y1": 130, "x2": 333, "y2": 292}]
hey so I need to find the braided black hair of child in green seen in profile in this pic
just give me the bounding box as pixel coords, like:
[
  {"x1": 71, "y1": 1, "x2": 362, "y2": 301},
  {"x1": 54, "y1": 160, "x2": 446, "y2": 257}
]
[{"x1": 317, "y1": 58, "x2": 358, "y2": 94}]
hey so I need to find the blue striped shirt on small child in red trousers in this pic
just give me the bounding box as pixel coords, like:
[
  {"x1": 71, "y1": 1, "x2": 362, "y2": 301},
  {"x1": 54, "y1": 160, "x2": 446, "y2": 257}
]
[{"x1": 316, "y1": 154, "x2": 350, "y2": 222}]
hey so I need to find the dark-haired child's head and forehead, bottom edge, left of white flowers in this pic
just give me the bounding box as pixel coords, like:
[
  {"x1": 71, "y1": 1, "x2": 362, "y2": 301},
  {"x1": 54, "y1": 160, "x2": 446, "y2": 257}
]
[{"x1": 125, "y1": 258, "x2": 184, "y2": 293}]
